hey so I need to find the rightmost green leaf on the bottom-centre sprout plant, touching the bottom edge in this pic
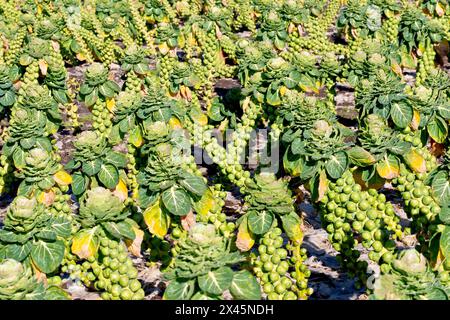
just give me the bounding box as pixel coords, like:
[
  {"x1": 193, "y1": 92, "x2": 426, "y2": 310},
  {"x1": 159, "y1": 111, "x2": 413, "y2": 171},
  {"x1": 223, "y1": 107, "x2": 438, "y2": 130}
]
[{"x1": 230, "y1": 270, "x2": 261, "y2": 300}]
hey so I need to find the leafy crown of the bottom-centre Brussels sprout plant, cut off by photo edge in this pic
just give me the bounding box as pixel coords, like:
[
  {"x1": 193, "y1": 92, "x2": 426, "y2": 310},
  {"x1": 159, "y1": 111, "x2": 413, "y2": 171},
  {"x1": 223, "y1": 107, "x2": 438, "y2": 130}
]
[{"x1": 164, "y1": 224, "x2": 260, "y2": 300}]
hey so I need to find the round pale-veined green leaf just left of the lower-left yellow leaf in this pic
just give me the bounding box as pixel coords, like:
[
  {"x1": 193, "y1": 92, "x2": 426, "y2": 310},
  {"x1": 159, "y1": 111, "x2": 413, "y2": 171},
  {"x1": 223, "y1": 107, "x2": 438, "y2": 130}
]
[{"x1": 31, "y1": 240, "x2": 65, "y2": 273}]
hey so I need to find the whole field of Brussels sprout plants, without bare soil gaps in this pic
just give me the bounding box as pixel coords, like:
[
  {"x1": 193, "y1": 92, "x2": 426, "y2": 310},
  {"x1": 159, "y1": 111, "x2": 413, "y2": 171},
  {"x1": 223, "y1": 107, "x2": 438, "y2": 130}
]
[{"x1": 0, "y1": 0, "x2": 450, "y2": 300}]
